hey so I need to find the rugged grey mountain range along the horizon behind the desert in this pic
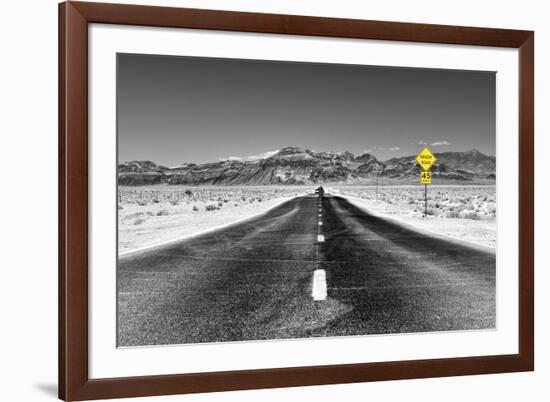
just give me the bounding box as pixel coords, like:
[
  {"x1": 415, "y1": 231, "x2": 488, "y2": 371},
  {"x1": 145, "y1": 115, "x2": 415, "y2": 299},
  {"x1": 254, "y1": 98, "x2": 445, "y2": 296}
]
[{"x1": 118, "y1": 147, "x2": 496, "y2": 185}]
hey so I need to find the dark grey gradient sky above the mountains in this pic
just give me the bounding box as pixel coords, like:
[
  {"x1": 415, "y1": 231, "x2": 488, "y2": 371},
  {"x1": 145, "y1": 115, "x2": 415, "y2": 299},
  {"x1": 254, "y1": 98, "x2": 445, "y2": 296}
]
[{"x1": 117, "y1": 54, "x2": 496, "y2": 166}]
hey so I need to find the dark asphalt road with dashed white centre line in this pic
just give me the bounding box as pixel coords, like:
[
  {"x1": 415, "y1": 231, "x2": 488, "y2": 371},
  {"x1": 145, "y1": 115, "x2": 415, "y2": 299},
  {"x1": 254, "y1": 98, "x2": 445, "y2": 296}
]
[{"x1": 117, "y1": 194, "x2": 496, "y2": 346}]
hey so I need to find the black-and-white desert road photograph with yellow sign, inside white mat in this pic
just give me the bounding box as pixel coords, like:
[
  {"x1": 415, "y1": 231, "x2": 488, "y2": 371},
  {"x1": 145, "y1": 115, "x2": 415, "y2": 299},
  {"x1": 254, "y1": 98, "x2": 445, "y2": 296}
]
[{"x1": 118, "y1": 53, "x2": 497, "y2": 348}]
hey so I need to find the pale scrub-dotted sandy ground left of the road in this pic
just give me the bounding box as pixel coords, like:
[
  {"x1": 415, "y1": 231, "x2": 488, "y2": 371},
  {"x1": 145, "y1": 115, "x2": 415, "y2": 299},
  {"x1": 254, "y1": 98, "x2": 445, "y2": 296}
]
[{"x1": 118, "y1": 186, "x2": 310, "y2": 254}]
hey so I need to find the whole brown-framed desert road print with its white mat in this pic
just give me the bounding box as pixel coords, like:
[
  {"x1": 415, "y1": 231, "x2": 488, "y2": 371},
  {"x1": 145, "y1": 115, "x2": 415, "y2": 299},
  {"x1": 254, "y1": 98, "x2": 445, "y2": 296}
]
[{"x1": 59, "y1": 2, "x2": 534, "y2": 400}]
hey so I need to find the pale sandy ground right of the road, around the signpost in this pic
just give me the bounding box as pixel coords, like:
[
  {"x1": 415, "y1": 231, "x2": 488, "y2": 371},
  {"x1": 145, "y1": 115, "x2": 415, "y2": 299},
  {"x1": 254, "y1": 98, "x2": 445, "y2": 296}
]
[{"x1": 329, "y1": 186, "x2": 497, "y2": 247}]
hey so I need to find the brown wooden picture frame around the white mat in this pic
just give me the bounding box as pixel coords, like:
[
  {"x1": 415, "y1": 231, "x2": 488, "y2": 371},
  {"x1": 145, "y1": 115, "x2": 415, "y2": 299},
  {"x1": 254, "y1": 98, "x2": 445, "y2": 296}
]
[{"x1": 59, "y1": 2, "x2": 534, "y2": 400}]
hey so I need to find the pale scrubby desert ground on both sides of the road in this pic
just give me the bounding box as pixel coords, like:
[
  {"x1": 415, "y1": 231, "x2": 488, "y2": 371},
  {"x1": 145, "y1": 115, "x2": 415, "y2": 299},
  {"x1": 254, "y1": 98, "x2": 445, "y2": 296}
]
[{"x1": 118, "y1": 185, "x2": 496, "y2": 254}]
